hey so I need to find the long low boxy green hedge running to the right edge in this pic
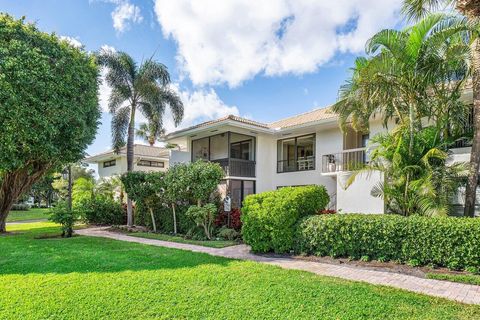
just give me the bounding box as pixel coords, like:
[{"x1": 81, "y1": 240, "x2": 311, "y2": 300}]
[{"x1": 295, "y1": 214, "x2": 480, "y2": 270}]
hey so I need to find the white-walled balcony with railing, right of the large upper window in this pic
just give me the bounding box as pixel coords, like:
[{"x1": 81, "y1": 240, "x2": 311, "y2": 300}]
[{"x1": 322, "y1": 148, "x2": 368, "y2": 174}]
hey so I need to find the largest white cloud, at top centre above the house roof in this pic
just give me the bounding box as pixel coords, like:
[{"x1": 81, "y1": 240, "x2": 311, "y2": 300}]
[{"x1": 155, "y1": 0, "x2": 402, "y2": 87}]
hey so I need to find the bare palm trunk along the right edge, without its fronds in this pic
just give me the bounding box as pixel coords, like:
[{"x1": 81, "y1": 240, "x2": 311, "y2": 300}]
[{"x1": 464, "y1": 38, "x2": 480, "y2": 217}]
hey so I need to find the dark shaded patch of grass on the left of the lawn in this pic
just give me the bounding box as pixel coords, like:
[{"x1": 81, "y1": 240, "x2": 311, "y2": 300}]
[{"x1": 0, "y1": 227, "x2": 232, "y2": 275}]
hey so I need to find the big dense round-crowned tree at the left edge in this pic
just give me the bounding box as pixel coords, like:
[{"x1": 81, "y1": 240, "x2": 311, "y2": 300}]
[{"x1": 0, "y1": 14, "x2": 100, "y2": 232}]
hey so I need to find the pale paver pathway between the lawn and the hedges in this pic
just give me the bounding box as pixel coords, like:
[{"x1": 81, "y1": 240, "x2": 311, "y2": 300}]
[{"x1": 75, "y1": 227, "x2": 480, "y2": 304}]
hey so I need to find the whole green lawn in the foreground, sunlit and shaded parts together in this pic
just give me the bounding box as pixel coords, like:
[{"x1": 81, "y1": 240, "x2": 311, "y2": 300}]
[{"x1": 0, "y1": 223, "x2": 480, "y2": 320}]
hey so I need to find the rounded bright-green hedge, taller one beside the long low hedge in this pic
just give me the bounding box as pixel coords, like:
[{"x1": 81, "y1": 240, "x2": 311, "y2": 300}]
[{"x1": 241, "y1": 186, "x2": 330, "y2": 253}]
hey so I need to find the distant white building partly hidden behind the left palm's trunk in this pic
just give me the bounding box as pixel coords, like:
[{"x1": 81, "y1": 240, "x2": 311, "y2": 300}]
[{"x1": 84, "y1": 144, "x2": 170, "y2": 178}]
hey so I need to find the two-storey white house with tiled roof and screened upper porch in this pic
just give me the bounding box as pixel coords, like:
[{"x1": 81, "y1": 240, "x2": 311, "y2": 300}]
[{"x1": 165, "y1": 89, "x2": 472, "y2": 213}]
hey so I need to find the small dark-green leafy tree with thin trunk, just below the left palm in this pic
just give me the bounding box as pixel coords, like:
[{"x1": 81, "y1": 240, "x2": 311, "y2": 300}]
[{"x1": 120, "y1": 171, "x2": 165, "y2": 232}]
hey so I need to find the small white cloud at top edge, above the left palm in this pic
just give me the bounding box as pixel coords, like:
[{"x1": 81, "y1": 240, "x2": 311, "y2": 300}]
[{"x1": 90, "y1": 0, "x2": 143, "y2": 33}]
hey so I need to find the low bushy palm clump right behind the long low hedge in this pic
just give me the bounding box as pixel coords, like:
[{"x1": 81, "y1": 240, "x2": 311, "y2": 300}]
[{"x1": 347, "y1": 127, "x2": 468, "y2": 216}]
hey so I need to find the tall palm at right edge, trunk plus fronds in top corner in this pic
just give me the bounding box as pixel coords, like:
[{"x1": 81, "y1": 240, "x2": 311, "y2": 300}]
[{"x1": 403, "y1": 0, "x2": 480, "y2": 217}]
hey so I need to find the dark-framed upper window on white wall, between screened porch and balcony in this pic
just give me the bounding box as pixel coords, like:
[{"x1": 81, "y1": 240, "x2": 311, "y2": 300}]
[{"x1": 277, "y1": 134, "x2": 315, "y2": 173}]
